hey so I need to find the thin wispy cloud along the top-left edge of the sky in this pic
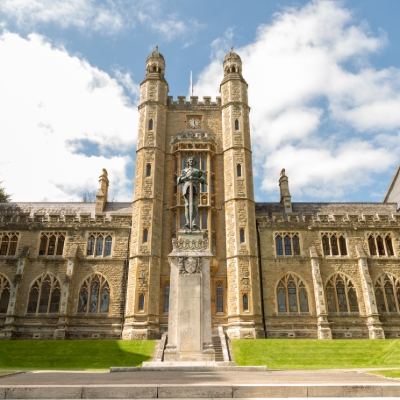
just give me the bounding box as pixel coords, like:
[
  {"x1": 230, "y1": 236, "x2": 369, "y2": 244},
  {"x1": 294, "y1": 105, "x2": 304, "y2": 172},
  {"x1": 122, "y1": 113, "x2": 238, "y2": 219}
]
[{"x1": 0, "y1": 0, "x2": 203, "y2": 40}]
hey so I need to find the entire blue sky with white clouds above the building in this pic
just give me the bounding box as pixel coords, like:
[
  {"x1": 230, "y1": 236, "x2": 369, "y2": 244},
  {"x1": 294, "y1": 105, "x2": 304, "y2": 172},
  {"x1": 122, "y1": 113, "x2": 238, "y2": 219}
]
[{"x1": 0, "y1": 0, "x2": 400, "y2": 202}]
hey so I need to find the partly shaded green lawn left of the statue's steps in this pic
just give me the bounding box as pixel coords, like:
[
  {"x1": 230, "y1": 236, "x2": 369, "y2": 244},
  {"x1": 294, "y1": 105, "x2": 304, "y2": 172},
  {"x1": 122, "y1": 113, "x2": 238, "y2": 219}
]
[{"x1": 0, "y1": 340, "x2": 155, "y2": 370}]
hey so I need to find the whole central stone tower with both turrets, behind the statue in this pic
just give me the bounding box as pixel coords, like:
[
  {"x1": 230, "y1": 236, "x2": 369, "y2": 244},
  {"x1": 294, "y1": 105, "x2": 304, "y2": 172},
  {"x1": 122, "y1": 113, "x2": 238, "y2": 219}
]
[{"x1": 123, "y1": 49, "x2": 263, "y2": 339}]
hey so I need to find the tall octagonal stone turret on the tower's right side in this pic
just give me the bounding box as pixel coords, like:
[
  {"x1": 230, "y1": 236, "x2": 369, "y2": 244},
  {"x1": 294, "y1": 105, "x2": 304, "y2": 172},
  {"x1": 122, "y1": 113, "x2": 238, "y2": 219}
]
[{"x1": 220, "y1": 48, "x2": 263, "y2": 338}]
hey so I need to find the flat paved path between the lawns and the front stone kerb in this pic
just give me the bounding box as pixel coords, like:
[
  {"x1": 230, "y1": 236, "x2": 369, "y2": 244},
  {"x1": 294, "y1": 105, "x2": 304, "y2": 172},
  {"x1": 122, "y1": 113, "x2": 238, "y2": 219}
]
[{"x1": 0, "y1": 370, "x2": 400, "y2": 386}]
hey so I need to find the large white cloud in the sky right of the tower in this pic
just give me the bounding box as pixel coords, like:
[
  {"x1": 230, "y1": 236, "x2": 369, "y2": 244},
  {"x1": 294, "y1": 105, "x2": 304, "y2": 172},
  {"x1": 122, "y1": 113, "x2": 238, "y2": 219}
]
[{"x1": 195, "y1": 0, "x2": 400, "y2": 200}]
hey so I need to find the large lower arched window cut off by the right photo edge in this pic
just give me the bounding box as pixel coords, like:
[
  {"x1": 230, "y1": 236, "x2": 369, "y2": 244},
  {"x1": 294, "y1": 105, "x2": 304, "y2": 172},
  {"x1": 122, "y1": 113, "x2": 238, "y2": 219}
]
[{"x1": 375, "y1": 273, "x2": 400, "y2": 312}]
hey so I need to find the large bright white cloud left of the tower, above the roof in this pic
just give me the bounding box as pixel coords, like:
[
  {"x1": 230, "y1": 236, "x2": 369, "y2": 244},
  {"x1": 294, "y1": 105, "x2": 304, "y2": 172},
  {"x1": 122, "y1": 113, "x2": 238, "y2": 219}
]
[{"x1": 0, "y1": 32, "x2": 138, "y2": 201}]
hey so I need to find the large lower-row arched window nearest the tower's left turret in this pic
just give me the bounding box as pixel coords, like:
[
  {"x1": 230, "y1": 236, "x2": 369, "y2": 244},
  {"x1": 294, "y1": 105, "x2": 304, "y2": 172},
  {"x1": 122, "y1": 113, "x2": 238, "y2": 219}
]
[{"x1": 78, "y1": 274, "x2": 110, "y2": 314}]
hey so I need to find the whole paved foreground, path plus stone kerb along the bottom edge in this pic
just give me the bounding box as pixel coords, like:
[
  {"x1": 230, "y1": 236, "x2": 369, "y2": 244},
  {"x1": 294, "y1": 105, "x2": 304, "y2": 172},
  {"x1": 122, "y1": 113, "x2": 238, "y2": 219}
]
[{"x1": 0, "y1": 370, "x2": 400, "y2": 399}]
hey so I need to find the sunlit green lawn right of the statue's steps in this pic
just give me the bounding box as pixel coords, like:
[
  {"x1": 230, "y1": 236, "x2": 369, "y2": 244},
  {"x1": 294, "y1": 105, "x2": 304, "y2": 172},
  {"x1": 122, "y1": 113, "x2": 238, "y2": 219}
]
[{"x1": 232, "y1": 339, "x2": 400, "y2": 369}]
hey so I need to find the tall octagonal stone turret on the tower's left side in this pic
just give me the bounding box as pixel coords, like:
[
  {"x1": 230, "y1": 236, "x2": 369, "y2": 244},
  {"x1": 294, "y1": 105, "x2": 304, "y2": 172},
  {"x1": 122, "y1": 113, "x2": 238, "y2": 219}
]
[{"x1": 123, "y1": 47, "x2": 168, "y2": 339}]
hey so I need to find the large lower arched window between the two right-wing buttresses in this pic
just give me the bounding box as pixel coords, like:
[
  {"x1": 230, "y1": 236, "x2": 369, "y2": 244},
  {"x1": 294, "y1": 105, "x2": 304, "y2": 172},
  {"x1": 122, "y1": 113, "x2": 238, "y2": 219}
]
[{"x1": 326, "y1": 273, "x2": 358, "y2": 313}]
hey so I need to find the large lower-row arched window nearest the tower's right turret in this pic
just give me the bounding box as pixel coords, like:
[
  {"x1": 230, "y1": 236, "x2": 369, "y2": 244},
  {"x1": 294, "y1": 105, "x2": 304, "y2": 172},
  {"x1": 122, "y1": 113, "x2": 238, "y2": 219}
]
[{"x1": 276, "y1": 274, "x2": 309, "y2": 313}]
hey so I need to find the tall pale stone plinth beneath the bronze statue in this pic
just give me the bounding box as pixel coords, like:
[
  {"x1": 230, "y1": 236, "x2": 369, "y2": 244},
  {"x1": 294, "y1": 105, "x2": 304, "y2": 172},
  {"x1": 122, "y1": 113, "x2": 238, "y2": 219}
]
[{"x1": 164, "y1": 231, "x2": 215, "y2": 362}]
